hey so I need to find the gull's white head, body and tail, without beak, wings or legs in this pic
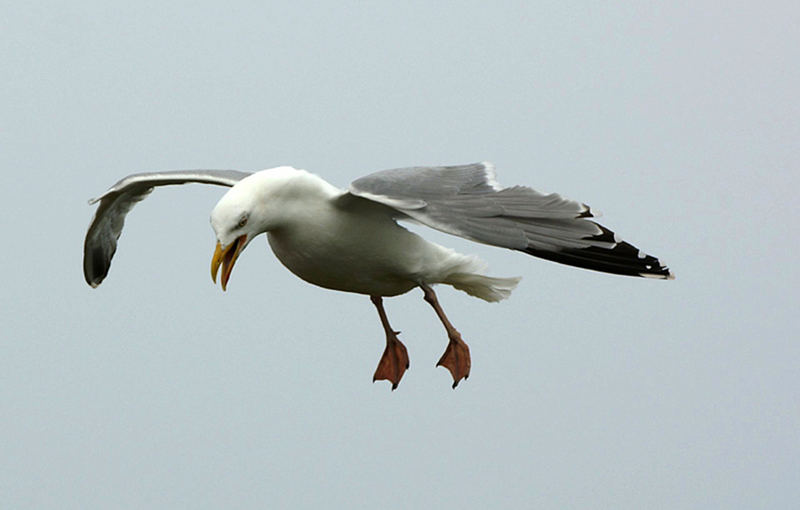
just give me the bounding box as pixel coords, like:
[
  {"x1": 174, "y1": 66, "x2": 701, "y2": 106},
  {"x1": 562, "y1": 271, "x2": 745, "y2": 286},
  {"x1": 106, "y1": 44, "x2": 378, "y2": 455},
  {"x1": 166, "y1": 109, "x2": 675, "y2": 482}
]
[{"x1": 211, "y1": 167, "x2": 519, "y2": 301}]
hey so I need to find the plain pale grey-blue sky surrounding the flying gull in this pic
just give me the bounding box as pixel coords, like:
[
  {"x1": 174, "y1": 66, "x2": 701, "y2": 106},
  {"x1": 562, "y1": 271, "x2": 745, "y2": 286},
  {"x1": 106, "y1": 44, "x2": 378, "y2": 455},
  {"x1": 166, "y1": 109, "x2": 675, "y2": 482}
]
[{"x1": 0, "y1": 1, "x2": 800, "y2": 509}]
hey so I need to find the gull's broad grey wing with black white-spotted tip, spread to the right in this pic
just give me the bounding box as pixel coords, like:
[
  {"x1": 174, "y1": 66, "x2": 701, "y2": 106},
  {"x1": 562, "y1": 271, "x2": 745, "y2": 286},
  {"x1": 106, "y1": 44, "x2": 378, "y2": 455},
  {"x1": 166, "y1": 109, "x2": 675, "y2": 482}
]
[{"x1": 349, "y1": 163, "x2": 673, "y2": 278}]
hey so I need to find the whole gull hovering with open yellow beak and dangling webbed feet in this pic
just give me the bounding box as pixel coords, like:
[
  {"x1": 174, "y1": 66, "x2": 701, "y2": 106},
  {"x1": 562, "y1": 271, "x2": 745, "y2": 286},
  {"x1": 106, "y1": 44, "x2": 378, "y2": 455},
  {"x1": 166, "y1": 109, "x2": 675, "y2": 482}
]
[{"x1": 83, "y1": 162, "x2": 674, "y2": 390}]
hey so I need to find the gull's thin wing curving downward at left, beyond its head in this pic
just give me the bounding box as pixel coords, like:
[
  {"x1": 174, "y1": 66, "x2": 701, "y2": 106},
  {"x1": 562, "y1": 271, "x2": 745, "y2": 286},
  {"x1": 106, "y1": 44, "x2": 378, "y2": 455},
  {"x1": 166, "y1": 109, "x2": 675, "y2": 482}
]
[{"x1": 83, "y1": 170, "x2": 250, "y2": 287}]
